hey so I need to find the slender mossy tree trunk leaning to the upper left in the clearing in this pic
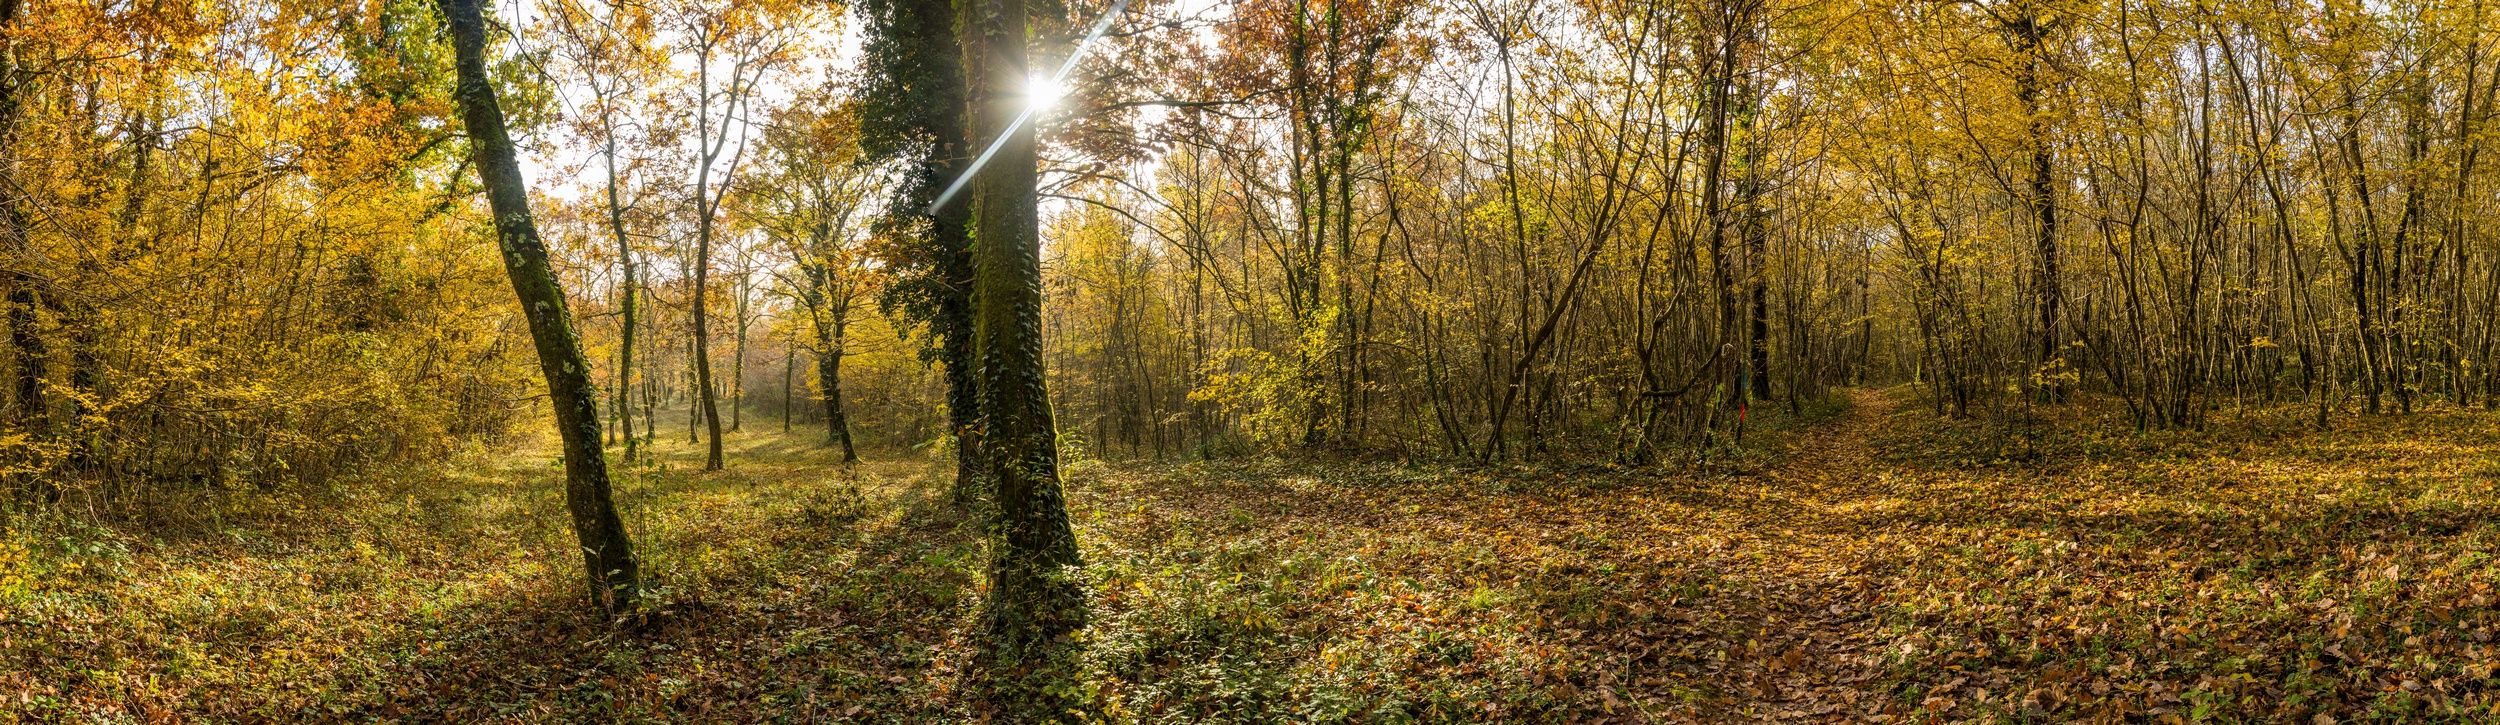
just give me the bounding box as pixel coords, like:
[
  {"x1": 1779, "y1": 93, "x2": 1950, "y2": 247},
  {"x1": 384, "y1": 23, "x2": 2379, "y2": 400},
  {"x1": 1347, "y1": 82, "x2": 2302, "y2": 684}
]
[{"x1": 443, "y1": 0, "x2": 640, "y2": 615}]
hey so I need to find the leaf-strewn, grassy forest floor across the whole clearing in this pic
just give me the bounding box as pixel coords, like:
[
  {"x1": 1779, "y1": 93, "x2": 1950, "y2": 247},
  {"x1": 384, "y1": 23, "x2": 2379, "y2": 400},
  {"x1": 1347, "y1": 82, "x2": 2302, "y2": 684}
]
[{"x1": 0, "y1": 390, "x2": 2500, "y2": 723}]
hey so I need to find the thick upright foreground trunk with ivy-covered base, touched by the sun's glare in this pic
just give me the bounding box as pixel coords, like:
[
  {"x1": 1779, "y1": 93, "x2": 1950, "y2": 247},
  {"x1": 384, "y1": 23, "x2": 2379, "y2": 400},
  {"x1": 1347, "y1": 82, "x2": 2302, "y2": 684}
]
[{"x1": 963, "y1": 0, "x2": 1085, "y2": 698}]
